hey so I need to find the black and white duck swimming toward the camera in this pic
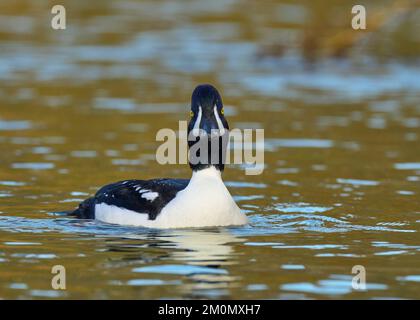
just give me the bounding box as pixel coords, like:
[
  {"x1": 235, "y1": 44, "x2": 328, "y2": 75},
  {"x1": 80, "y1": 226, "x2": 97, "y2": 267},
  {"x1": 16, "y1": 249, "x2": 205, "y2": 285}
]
[{"x1": 71, "y1": 84, "x2": 248, "y2": 229}]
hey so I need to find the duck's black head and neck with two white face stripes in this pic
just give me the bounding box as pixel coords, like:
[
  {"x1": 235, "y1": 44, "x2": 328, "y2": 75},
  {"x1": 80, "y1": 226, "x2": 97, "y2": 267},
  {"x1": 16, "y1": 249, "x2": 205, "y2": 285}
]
[{"x1": 188, "y1": 84, "x2": 229, "y2": 171}]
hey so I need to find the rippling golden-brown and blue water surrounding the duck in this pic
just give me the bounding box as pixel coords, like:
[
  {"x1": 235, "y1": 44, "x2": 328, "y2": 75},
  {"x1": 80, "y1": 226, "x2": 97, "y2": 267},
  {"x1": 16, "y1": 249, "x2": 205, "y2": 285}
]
[{"x1": 0, "y1": 1, "x2": 420, "y2": 299}]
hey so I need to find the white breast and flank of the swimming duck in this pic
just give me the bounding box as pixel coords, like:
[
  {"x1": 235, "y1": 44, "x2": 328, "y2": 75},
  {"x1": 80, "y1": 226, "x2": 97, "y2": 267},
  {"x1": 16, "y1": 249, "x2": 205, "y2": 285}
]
[{"x1": 95, "y1": 167, "x2": 248, "y2": 228}]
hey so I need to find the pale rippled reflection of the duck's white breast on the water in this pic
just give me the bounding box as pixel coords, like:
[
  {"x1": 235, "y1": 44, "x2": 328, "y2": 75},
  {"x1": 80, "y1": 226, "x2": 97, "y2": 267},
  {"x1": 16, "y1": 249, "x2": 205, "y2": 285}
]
[{"x1": 133, "y1": 229, "x2": 244, "y2": 297}]
